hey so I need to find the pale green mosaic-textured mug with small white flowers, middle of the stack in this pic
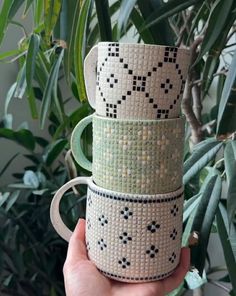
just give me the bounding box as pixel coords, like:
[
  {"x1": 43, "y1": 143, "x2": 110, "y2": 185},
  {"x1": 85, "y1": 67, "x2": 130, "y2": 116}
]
[{"x1": 71, "y1": 114, "x2": 185, "y2": 194}]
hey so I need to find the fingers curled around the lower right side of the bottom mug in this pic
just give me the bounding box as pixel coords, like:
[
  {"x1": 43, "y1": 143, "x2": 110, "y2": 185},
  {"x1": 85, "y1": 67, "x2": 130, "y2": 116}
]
[{"x1": 162, "y1": 248, "x2": 190, "y2": 293}]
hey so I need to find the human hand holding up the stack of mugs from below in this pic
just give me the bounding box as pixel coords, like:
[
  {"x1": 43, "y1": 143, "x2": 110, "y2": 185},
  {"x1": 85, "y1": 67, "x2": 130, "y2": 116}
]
[{"x1": 63, "y1": 219, "x2": 190, "y2": 296}]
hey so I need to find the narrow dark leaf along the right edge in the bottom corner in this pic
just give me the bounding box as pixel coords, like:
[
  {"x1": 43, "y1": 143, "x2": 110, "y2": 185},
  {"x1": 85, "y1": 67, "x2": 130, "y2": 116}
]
[{"x1": 216, "y1": 204, "x2": 236, "y2": 291}]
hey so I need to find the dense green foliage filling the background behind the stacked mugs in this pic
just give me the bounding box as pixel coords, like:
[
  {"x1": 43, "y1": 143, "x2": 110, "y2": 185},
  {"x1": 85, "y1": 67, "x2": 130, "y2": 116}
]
[{"x1": 0, "y1": 0, "x2": 236, "y2": 295}]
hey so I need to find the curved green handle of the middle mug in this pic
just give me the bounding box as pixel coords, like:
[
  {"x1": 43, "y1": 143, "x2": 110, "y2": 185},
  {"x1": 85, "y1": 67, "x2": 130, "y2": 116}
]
[{"x1": 70, "y1": 114, "x2": 93, "y2": 172}]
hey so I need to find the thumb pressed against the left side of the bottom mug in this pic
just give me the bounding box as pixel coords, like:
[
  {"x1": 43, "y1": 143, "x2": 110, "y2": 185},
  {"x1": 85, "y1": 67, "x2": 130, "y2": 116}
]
[{"x1": 66, "y1": 219, "x2": 88, "y2": 263}]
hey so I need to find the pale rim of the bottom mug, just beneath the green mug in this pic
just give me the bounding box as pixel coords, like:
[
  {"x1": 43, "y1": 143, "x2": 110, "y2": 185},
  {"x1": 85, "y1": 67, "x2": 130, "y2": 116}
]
[{"x1": 87, "y1": 176, "x2": 184, "y2": 199}]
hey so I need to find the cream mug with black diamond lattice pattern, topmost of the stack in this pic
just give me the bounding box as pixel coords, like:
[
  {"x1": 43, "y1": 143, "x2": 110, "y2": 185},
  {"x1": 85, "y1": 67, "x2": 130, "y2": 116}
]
[{"x1": 84, "y1": 42, "x2": 190, "y2": 120}]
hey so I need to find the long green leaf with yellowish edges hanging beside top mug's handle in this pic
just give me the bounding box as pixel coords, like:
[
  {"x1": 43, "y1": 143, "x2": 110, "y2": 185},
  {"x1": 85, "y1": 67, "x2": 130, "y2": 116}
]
[{"x1": 74, "y1": 0, "x2": 93, "y2": 102}]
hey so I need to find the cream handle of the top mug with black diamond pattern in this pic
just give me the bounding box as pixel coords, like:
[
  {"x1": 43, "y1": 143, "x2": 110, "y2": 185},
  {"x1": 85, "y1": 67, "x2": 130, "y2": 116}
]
[{"x1": 84, "y1": 45, "x2": 98, "y2": 109}]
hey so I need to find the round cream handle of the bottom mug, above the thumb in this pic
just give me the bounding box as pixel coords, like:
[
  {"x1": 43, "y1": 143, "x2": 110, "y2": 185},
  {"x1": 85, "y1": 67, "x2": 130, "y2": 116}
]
[{"x1": 50, "y1": 177, "x2": 90, "y2": 241}]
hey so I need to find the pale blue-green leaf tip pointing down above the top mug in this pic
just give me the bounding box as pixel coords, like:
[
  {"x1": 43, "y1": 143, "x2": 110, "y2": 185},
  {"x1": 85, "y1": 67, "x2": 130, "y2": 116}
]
[{"x1": 117, "y1": 0, "x2": 137, "y2": 38}]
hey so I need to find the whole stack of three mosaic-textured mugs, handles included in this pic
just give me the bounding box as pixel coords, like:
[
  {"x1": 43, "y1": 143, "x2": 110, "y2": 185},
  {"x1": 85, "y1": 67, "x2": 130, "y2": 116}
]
[{"x1": 51, "y1": 42, "x2": 189, "y2": 282}]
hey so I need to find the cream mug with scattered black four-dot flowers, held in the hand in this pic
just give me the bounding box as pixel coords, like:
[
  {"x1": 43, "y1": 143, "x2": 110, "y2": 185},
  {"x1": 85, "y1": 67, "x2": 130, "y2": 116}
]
[{"x1": 50, "y1": 177, "x2": 183, "y2": 283}]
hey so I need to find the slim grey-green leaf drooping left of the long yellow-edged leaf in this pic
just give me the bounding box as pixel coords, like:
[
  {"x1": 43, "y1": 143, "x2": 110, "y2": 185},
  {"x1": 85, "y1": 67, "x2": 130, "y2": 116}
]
[{"x1": 40, "y1": 50, "x2": 64, "y2": 128}]
